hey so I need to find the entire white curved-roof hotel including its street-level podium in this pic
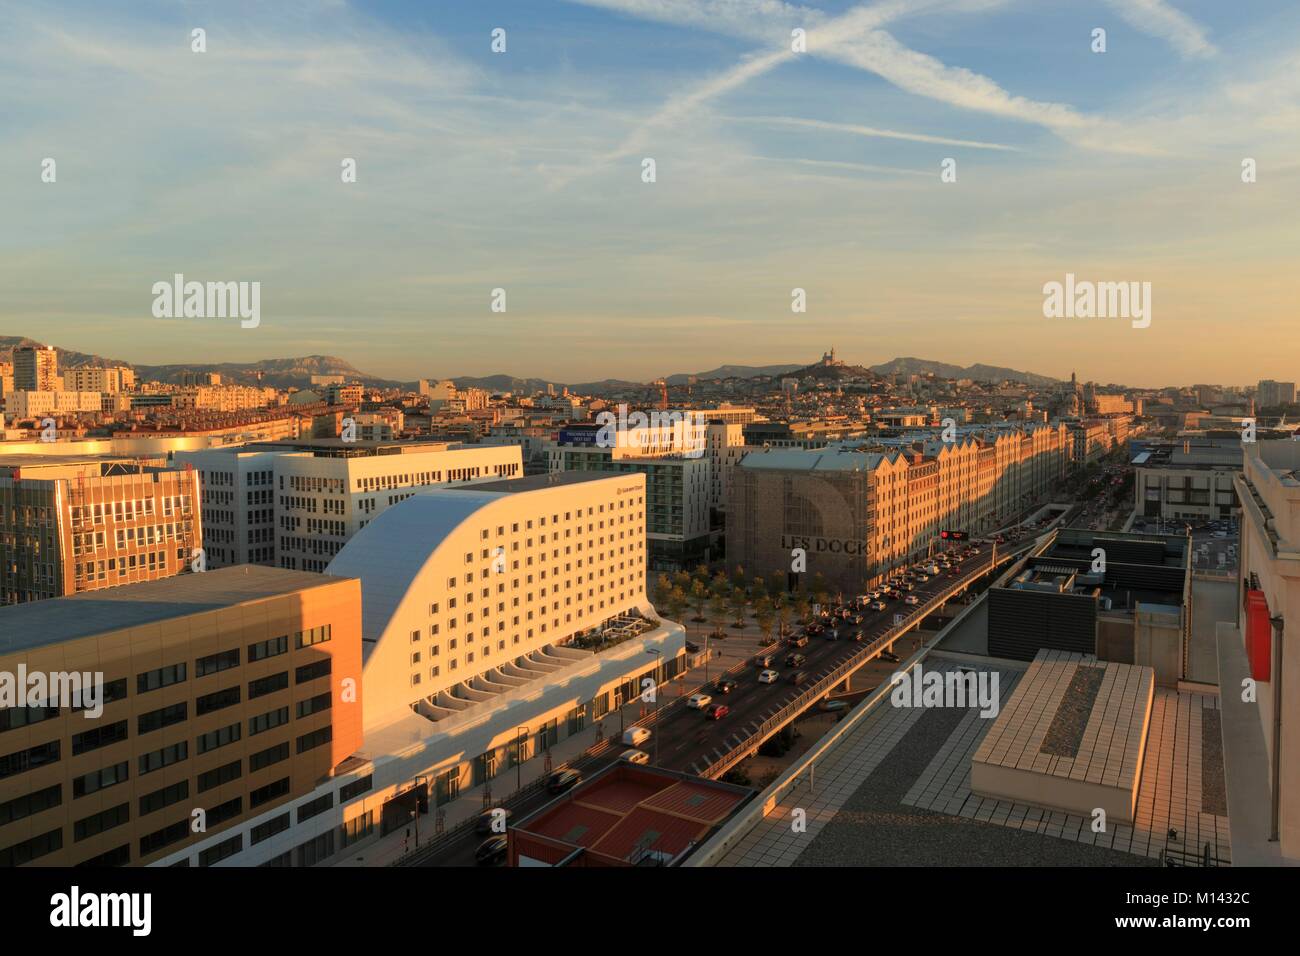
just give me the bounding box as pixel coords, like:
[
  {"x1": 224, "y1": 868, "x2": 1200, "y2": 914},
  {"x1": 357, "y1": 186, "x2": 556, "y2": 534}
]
[{"x1": 160, "y1": 473, "x2": 685, "y2": 866}]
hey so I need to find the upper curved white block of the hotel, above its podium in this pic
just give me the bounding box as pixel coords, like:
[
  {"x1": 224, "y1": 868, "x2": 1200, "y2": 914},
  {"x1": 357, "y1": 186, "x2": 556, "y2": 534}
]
[{"x1": 328, "y1": 473, "x2": 655, "y2": 731}]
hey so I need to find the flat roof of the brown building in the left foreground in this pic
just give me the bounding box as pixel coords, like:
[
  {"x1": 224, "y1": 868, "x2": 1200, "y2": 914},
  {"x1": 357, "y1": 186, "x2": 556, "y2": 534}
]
[{"x1": 0, "y1": 564, "x2": 347, "y2": 653}]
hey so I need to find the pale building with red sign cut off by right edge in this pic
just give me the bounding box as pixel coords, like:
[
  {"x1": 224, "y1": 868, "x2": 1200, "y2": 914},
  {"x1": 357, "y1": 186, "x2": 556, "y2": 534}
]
[{"x1": 1217, "y1": 441, "x2": 1300, "y2": 866}]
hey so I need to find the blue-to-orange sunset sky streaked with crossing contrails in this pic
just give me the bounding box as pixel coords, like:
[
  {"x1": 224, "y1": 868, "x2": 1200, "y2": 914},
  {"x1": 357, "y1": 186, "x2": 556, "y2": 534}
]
[{"x1": 0, "y1": 0, "x2": 1300, "y2": 386}]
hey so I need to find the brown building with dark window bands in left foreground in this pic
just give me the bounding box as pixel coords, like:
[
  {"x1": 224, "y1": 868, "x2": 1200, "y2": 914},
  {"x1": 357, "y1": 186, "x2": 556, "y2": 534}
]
[{"x1": 0, "y1": 567, "x2": 367, "y2": 866}]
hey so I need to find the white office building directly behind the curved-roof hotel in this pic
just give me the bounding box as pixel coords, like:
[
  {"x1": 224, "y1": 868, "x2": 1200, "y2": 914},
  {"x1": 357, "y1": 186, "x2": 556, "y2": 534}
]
[{"x1": 176, "y1": 440, "x2": 524, "y2": 571}]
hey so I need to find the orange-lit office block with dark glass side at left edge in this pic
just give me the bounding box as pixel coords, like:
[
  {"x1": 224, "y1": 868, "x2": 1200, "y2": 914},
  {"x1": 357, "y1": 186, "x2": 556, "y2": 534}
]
[{"x1": 0, "y1": 455, "x2": 203, "y2": 604}]
